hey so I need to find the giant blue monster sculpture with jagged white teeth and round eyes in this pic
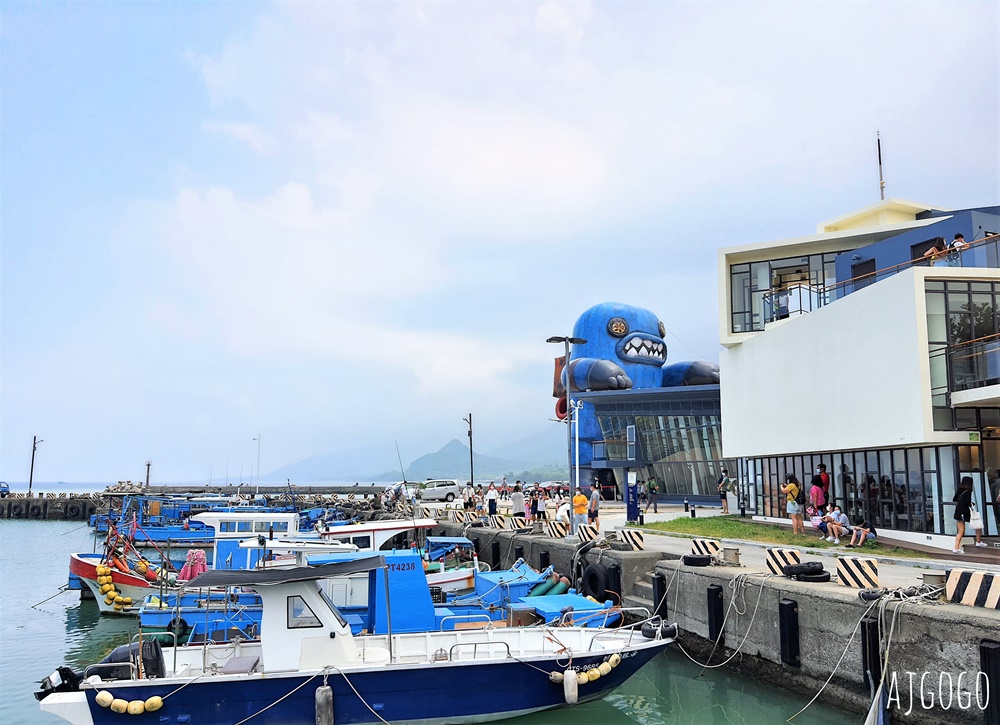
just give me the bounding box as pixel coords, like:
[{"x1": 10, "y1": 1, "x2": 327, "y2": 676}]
[{"x1": 554, "y1": 302, "x2": 719, "y2": 483}]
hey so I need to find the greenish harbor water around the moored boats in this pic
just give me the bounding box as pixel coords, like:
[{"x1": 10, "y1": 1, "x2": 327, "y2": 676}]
[{"x1": 0, "y1": 520, "x2": 863, "y2": 725}]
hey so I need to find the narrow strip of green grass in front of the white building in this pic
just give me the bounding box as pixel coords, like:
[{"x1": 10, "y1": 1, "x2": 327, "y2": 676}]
[{"x1": 643, "y1": 516, "x2": 927, "y2": 559}]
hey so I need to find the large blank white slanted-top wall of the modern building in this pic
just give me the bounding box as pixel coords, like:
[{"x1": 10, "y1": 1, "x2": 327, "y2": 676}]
[{"x1": 720, "y1": 268, "x2": 968, "y2": 458}]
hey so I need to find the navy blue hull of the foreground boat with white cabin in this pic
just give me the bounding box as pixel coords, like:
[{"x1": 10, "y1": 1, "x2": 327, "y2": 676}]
[{"x1": 50, "y1": 640, "x2": 670, "y2": 725}]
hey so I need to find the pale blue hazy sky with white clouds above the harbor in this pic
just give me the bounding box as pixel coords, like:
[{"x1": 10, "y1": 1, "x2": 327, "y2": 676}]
[{"x1": 0, "y1": 0, "x2": 1000, "y2": 482}]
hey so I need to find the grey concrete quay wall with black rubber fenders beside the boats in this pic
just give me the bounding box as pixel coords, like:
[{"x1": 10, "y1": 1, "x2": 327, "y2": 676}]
[{"x1": 442, "y1": 523, "x2": 1000, "y2": 725}]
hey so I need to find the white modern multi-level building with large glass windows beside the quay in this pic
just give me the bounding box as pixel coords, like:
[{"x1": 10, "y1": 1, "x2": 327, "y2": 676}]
[{"x1": 718, "y1": 200, "x2": 1000, "y2": 549}]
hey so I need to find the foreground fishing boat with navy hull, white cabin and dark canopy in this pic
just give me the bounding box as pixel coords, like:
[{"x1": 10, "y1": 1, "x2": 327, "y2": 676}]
[{"x1": 35, "y1": 555, "x2": 676, "y2": 725}]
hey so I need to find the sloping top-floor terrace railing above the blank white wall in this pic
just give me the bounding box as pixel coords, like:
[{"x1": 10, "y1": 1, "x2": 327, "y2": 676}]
[{"x1": 761, "y1": 234, "x2": 1000, "y2": 324}]
